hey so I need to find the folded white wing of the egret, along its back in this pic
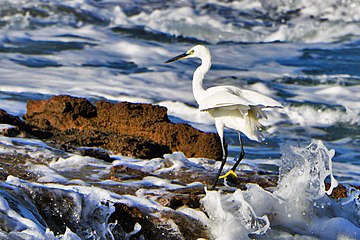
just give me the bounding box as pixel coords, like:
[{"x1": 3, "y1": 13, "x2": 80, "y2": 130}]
[{"x1": 199, "y1": 86, "x2": 282, "y2": 111}]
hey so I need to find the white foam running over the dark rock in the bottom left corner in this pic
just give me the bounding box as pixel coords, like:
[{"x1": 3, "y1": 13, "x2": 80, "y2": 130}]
[{"x1": 6, "y1": 176, "x2": 116, "y2": 239}]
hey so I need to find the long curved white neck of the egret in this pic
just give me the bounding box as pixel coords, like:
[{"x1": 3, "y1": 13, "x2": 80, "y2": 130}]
[{"x1": 192, "y1": 56, "x2": 211, "y2": 104}]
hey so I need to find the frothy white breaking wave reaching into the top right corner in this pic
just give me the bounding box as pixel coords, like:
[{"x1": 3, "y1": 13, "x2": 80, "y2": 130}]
[{"x1": 113, "y1": 0, "x2": 360, "y2": 43}]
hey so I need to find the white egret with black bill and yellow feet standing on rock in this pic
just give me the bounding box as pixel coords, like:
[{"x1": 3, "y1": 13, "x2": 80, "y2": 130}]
[{"x1": 165, "y1": 45, "x2": 282, "y2": 188}]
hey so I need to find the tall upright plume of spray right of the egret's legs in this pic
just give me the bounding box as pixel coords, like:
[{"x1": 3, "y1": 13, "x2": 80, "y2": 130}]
[{"x1": 276, "y1": 140, "x2": 338, "y2": 199}]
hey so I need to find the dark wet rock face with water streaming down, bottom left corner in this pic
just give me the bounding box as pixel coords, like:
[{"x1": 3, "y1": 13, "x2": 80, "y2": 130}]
[{"x1": 9, "y1": 185, "x2": 112, "y2": 239}]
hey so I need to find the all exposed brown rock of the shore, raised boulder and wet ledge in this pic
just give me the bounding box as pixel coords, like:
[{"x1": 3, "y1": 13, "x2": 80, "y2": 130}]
[{"x1": 0, "y1": 96, "x2": 354, "y2": 239}]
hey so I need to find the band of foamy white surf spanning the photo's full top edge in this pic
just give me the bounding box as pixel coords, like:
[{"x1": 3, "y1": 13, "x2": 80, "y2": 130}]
[{"x1": 4, "y1": 0, "x2": 360, "y2": 43}]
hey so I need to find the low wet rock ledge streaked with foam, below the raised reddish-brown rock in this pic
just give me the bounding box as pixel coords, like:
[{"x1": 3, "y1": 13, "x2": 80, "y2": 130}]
[{"x1": 0, "y1": 145, "x2": 275, "y2": 240}]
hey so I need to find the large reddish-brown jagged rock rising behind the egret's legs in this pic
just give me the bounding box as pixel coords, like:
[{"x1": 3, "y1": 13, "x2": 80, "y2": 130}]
[{"x1": 25, "y1": 96, "x2": 222, "y2": 159}]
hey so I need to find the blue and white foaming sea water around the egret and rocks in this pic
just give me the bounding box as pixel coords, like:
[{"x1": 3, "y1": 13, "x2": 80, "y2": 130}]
[{"x1": 0, "y1": 0, "x2": 360, "y2": 239}]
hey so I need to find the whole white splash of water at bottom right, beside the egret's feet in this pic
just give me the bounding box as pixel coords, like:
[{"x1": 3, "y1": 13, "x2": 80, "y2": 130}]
[{"x1": 202, "y1": 140, "x2": 360, "y2": 239}]
